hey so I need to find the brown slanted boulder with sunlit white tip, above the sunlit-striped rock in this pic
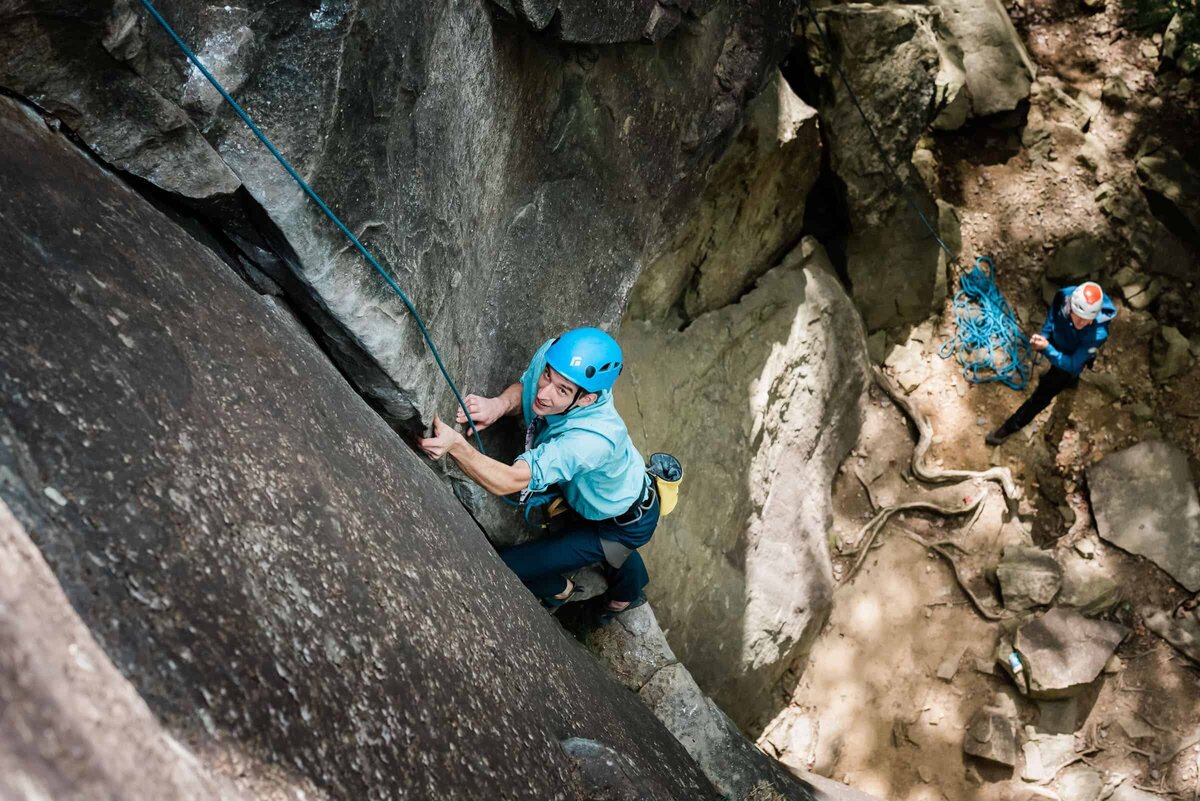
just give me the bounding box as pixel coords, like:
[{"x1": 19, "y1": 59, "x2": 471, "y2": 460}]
[{"x1": 629, "y1": 72, "x2": 821, "y2": 320}]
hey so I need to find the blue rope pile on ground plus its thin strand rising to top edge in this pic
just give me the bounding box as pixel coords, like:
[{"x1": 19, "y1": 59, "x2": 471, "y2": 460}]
[{"x1": 804, "y1": 2, "x2": 1033, "y2": 390}]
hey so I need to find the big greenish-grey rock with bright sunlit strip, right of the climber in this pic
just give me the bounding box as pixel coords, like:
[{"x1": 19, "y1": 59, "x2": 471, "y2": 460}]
[{"x1": 617, "y1": 239, "x2": 866, "y2": 725}]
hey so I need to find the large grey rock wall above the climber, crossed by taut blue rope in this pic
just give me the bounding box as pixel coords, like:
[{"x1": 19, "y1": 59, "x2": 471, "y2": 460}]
[{"x1": 0, "y1": 0, "x2": 796, "y2": 438}]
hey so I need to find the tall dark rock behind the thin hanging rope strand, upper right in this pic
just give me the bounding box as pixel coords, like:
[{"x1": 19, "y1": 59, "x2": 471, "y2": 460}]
[{"x1": 799, "y1": 5, "x2": 965, "y2": 331}]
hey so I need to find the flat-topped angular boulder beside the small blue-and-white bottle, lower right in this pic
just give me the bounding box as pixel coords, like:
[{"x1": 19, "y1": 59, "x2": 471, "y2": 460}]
[{"x1": 1013, "y1": 608, "x2": 1128, "y2": 700}]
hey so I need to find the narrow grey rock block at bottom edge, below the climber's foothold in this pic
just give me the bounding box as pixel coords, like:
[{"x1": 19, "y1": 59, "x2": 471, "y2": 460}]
[{"x1": 638, "y1": 664, "x2": 816, "y2": 801}]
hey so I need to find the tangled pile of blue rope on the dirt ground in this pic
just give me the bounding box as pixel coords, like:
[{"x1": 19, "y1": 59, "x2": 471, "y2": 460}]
[{"x1": 937, "y1": 255, "x2": 1033, "y2": 390}]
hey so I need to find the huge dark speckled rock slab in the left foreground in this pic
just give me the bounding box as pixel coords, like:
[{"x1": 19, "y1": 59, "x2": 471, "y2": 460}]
[{"x1": 0, "y1": 100, "x2": 718, "y2": 801}]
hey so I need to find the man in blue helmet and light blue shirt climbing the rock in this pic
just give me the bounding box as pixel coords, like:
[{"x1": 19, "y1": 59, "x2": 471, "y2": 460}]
[{"x1": 419, "y1": 329, "x2": 659, "y2": 616}]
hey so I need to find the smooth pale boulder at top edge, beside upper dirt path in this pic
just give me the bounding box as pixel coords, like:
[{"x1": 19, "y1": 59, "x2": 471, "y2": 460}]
[{"x1": 931, "y1": 0, "x2": 1037, "y2": 118}]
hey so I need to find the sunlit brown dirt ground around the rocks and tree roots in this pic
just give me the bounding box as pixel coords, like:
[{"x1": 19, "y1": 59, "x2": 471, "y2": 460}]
[{"x1": 760, "y1": 0, "x2": 1200, "y2": 801}]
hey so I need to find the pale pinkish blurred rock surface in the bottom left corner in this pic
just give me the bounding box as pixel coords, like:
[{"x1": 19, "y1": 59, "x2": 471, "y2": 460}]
[{"x1": 0, "y1": 501, "x2": 258, "y2": 801}]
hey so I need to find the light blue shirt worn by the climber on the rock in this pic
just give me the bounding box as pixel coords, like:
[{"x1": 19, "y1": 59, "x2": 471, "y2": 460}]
[{"x1": 517, "y1": 339, "x2": 647, "y2": 520}]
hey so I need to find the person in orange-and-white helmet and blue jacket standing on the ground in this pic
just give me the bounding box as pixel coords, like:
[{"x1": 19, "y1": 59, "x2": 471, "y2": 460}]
[{"x1": 984, "y1": 281, "x2": 1117, "y2": 445}]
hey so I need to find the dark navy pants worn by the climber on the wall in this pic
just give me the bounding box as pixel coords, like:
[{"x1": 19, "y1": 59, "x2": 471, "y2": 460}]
[{"x1": 500, "y1": 499, "x2": 659, "y2": 601}]
